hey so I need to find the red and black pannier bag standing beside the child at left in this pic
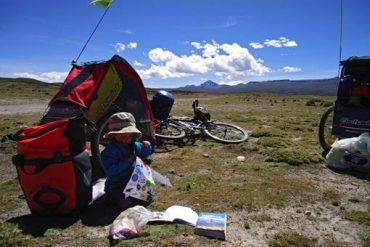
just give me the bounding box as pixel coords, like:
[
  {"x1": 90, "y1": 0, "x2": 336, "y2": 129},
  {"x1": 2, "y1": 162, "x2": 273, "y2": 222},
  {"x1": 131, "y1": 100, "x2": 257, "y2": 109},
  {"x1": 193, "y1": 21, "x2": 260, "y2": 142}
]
[{"x1": 13, "y1": 118, "x2": 92, "y2": 215}]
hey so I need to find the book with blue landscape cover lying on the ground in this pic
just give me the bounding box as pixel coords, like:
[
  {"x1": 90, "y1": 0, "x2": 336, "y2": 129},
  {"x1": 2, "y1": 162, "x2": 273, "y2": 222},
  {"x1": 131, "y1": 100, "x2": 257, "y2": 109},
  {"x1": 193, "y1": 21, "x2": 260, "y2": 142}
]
[{"x1": 194, "y1": 213, "x2": 227, "y2": 240}]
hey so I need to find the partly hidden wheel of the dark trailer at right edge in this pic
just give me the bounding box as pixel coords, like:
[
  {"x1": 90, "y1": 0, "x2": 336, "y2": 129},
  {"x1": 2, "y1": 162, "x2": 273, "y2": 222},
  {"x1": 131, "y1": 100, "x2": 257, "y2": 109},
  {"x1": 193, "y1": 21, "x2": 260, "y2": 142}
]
[{"x1": 319, "y1": 106, "x2": 336, "y2": 152}]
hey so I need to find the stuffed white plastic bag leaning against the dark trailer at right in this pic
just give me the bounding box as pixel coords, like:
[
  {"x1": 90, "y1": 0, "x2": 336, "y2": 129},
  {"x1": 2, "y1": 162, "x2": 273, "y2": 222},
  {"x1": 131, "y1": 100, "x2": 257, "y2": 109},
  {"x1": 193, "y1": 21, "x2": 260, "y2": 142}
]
[{"x1": 326, "y1": 132, "x2": 370, "y2": 172}]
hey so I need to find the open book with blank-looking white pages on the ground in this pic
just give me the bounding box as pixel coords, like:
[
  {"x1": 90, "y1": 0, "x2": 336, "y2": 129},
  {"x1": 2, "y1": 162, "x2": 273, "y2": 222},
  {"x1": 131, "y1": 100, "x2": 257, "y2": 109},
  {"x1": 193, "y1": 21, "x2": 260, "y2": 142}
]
[{"x1": 148, "y1": 205, "x2": 198, "y2": 226}]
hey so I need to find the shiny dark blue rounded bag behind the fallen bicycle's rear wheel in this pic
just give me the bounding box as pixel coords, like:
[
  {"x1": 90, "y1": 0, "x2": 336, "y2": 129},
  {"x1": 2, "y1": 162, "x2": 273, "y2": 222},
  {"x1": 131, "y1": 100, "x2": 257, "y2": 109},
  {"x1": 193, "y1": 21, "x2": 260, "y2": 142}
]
[{"x1": 150, "y1": 90, "x2": 175, "y2": 120}]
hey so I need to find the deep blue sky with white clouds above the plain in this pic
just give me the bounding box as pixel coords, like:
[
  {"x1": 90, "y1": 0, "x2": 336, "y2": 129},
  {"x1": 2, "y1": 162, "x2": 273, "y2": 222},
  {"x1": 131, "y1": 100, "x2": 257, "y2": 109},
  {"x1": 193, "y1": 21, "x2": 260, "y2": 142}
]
[{"x1": 0, "y1": 0, "x2": 370, "y2": 88}]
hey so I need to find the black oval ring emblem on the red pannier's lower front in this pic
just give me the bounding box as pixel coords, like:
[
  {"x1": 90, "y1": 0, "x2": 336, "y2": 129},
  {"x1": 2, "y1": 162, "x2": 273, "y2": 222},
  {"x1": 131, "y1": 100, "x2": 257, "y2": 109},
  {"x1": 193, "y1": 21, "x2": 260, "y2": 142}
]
[{"x1": 33, "y1": 185, "x2": 67, "y2": 214}]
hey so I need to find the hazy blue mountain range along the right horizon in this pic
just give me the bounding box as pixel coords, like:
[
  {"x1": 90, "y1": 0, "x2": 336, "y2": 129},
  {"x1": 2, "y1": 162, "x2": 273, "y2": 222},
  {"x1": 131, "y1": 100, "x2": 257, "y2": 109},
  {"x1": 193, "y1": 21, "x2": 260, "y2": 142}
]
[{"x1": 175, "y1": 77, "x2": 339, "y2": 95}]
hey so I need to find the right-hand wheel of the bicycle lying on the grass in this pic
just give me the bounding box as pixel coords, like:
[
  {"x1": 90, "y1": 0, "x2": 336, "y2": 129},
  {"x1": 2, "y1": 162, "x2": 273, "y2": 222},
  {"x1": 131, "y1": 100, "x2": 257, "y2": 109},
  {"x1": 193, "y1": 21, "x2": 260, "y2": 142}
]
[{"x1": 204, "y1": 122, "x2": 248, "y2": 144}]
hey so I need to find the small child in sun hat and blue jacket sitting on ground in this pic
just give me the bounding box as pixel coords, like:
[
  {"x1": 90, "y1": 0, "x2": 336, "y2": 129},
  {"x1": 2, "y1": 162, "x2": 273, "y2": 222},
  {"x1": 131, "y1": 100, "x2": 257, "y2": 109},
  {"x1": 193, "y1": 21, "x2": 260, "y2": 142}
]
[{"x1": 101, "y1": 112, "x2": 152, "y2": 210}]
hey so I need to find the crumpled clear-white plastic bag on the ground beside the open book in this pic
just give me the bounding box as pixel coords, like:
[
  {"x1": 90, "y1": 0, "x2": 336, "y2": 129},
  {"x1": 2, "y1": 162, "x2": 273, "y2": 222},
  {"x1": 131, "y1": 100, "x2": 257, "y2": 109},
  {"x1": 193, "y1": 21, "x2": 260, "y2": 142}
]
[{"x1": 109, "y1": 206, "x2": 152, "y2": 239}]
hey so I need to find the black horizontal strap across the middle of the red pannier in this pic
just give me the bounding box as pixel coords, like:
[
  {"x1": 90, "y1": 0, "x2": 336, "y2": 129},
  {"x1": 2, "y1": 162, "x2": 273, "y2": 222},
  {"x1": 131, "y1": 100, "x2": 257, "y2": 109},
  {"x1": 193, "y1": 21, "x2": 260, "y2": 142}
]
[{"x1": 12, "y1": 153, "x2": 72, "y2": 175}]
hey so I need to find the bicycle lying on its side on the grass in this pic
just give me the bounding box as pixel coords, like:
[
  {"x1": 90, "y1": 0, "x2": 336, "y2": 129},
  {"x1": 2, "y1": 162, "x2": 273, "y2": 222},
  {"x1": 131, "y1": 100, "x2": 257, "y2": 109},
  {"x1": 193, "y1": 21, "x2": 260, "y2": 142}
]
[{"x1": 155, "y1": 100, "x2": 248, "y2": 144}]
